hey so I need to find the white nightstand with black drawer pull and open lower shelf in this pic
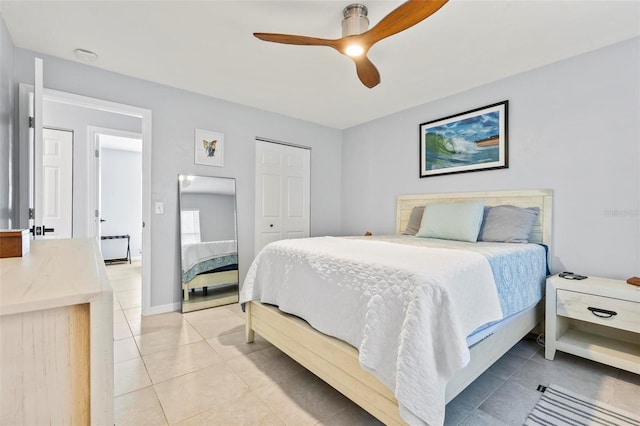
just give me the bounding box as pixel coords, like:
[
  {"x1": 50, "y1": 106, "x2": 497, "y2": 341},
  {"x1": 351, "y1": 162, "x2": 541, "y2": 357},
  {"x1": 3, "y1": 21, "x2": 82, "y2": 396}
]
[{"x1": 544, "y1": 275, "x2": 640, "y2": 374}]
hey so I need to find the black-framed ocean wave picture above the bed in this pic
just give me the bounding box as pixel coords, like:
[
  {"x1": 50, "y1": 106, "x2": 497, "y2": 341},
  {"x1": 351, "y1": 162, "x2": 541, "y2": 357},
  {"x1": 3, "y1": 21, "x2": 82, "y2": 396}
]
[{"x1": 420, "y1": 101, "x2": 509, "y2": 178}]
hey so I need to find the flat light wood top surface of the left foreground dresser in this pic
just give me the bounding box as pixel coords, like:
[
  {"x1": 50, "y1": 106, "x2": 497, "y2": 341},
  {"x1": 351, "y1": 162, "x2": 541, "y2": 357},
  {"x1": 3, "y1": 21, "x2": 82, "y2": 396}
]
[{"x1": 0, "y1": 238, "x2": 111, "y2": 315}]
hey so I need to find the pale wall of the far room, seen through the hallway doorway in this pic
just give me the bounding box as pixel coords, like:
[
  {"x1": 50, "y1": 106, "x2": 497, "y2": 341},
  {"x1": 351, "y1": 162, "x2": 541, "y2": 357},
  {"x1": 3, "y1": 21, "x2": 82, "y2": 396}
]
[{"x1": 100, "y1": 148, "x2": 142, "y2": 259}]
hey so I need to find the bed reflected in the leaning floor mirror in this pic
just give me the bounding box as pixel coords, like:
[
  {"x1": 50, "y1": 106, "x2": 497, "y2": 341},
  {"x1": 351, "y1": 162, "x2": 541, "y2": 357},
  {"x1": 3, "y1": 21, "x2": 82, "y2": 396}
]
[{"x1": 182, "y1": 240, "x2": 238, "y2": 302}]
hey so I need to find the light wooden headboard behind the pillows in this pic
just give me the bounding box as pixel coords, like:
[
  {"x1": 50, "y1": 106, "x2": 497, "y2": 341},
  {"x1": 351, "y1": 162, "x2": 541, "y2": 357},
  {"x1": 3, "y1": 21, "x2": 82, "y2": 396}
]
[{"x1": 396, "y1": 189, "x2": 553, "y2": 245}]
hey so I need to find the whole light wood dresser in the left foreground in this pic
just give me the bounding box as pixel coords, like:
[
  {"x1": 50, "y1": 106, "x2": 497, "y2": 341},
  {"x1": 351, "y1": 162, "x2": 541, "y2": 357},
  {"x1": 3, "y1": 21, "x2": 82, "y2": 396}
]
[{"x1": 0, "y1": 239, "x2": 113, "y2": 426}]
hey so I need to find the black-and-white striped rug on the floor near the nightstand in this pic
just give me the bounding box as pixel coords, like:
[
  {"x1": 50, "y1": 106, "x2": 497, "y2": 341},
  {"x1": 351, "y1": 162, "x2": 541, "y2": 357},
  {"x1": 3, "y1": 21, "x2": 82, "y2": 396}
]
[{"x1": 524, "y1": 384, "x2": 640, "y2": 426}]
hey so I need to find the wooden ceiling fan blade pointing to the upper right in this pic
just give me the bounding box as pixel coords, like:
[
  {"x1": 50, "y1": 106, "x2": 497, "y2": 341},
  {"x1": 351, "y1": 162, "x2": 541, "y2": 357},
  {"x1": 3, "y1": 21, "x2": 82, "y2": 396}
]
[{"x1": 361, "y1": 0, "x2": 449, "y2": 45}]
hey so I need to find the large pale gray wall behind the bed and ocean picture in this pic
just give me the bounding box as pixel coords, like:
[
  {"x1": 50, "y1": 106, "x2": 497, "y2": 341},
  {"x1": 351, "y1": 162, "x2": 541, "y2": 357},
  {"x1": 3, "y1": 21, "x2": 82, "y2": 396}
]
[{"x1": 342, "y1": 38, "x2": 640, "y2": 278}]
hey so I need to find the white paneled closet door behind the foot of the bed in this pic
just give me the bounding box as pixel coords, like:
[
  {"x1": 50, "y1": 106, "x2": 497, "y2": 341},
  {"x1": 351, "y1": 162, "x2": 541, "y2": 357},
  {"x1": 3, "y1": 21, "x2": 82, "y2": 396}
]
[{"x1": 255, "y1": 140, "x2": 311, "y2": 254}]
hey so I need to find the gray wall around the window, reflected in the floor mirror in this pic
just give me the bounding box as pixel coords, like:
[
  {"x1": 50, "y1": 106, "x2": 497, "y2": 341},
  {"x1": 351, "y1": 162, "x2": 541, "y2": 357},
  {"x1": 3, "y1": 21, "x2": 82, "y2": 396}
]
[{"x1": 180, "y1": 193, "x2": 236, "y2": 242}]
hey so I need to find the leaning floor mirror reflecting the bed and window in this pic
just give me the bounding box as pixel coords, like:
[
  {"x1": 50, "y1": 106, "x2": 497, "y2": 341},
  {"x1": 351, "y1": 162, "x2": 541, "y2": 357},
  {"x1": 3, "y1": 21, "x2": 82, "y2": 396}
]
[{"x1": 178, "y1": 175, "x2": 238, "y2": 313}]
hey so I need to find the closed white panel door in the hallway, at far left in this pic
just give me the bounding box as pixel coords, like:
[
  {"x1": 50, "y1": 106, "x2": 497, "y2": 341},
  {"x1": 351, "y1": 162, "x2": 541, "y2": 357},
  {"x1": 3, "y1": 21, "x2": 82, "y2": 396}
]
[{"x1": 36, "y1": 129, "x2": 73, "y2": 238}]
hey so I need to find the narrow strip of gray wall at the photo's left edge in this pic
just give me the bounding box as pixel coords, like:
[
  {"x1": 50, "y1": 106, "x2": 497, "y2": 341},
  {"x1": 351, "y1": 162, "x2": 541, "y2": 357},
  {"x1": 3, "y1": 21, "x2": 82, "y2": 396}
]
[{"x1": 0, "y1": 14, "x2": 17, "y2": 229}]
